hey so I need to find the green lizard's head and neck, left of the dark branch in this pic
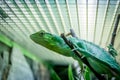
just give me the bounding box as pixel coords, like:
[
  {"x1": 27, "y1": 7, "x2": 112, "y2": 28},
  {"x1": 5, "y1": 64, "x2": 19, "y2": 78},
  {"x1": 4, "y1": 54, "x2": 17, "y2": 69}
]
[{"x1": 30, "y1": 30, "x2": 71, "y2": 56}]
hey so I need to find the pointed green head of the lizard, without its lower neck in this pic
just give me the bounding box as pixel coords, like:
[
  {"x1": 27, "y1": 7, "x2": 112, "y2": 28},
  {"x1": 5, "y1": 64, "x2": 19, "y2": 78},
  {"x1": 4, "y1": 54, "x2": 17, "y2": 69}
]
[{"x1": 30, "y1": 30, "x2": 63, "y2": 48}]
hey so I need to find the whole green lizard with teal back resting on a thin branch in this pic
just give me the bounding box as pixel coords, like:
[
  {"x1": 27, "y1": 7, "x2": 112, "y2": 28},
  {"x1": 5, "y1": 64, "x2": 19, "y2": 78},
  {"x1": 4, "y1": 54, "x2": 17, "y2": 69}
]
[{"x1": 30, "y1": 30, "x2": 120, "y2": 80}]
